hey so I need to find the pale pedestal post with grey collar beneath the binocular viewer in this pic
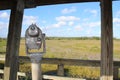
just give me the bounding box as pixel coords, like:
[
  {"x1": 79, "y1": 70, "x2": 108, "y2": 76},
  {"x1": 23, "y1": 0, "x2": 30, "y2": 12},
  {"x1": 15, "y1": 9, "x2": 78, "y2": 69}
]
[{"x1": 30, "y1": 53, "x2": 42, "y2": 80}]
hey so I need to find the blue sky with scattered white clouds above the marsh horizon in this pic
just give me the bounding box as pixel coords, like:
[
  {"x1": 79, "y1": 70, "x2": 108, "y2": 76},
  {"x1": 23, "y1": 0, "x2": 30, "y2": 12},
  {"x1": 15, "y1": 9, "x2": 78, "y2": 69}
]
[{"x1": 0, "y1": 1, "x2": 120, "y2": 38}]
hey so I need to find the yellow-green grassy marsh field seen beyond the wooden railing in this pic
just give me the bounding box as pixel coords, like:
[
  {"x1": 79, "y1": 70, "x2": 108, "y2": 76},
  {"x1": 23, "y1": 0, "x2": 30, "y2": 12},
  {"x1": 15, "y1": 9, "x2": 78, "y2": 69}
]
[{"x1": 0, "y1": 37, "x2": 120, "y2": 79}]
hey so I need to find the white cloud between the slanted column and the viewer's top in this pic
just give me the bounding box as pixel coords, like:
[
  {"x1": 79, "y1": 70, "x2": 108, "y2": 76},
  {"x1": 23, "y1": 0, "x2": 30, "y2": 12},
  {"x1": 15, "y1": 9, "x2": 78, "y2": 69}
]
[{"x1": 23, "y1": 15, "x2": 38, "y2": 25}]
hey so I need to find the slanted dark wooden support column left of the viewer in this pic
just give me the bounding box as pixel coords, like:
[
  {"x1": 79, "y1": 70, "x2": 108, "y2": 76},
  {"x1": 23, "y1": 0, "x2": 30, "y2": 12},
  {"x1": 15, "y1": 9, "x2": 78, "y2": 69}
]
[{"x1": 4, "y1": 0, "x2": 24, "y2": 80}]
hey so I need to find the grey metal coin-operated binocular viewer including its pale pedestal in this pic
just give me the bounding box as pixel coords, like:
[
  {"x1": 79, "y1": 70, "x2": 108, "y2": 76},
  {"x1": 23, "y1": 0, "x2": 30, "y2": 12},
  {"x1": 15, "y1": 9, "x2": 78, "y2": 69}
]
[{"x1": 25, "y1": 24, "x2": 46, "y2": 80}]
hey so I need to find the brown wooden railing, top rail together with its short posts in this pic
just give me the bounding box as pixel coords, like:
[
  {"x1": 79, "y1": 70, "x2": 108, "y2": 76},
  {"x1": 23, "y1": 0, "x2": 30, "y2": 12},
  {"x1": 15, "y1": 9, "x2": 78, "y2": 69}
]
[{"x1": 0, "y1": 56, "x2": 120, "y2": 79}]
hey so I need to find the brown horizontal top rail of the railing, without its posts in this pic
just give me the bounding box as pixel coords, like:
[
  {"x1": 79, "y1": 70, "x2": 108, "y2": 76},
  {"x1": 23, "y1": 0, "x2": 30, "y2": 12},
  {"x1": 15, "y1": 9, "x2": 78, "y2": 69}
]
[{"x1": 0, "y1": 56, "x2": 120, "y2": 67}]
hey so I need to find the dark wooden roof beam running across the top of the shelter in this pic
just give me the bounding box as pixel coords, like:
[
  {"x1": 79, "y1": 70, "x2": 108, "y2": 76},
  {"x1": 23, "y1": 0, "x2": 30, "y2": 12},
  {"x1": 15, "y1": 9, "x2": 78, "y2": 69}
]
[{"x1": 0, "y1": 0, "x2": 119, "y2": 10}]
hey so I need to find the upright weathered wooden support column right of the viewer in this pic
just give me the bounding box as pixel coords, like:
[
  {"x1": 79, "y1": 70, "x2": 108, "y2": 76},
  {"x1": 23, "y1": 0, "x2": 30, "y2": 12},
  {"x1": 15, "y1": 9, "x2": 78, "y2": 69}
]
[{"x1": 100, "y1": 0, "x2": 113, "y2": 80}]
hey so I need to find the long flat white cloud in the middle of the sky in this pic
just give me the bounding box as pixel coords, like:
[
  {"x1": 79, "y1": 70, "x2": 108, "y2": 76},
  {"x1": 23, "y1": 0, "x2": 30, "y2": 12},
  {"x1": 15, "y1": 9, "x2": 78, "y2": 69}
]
[{"x1": 56, "y1": 16, "x2": 80, "y2": 21}]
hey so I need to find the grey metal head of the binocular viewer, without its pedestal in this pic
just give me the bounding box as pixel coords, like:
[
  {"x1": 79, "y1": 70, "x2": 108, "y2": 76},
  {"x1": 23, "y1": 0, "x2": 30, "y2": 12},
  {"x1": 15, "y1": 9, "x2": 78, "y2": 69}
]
[{"x1": 25, "y1": 24, "x2": 45, "y2": 54}]
